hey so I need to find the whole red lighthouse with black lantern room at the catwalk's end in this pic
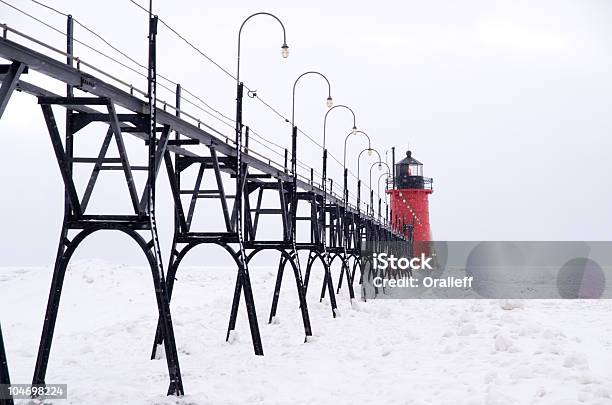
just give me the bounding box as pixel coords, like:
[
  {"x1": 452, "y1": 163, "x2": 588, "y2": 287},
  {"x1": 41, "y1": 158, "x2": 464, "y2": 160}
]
[{"x1": 387, "y1": 151, "x2": 433, "y2": 242}]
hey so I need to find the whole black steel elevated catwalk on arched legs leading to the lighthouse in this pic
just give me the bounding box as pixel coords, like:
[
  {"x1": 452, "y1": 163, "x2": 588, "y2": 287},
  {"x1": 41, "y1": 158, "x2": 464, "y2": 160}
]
[{"x1": 0, "y1": 11, "x2": 410, "y2": 395}]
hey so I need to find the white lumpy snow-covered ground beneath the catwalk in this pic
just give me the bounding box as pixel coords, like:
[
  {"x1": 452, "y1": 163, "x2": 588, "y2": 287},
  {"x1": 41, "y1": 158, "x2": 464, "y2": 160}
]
[{"x1": 0, "y1": 261, "x2": 612, "y2": 405}]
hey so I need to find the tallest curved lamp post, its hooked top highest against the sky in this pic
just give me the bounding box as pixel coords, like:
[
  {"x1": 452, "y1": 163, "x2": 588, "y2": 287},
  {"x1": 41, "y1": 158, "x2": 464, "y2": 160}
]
[{"x1": 235, "y1": 12, "x2": 289, "y2": 241}]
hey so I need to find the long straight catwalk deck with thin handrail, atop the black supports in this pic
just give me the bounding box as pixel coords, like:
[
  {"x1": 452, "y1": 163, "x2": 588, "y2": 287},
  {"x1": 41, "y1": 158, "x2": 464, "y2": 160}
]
[{"x1": 0, "y1": 33, "x2": 401, "y2": 236}]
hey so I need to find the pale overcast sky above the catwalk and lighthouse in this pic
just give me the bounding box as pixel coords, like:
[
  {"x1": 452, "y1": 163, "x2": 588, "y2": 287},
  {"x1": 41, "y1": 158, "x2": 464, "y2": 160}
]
[{"x1": 0, "y1": 0, "x2": 612, "y2": 265}]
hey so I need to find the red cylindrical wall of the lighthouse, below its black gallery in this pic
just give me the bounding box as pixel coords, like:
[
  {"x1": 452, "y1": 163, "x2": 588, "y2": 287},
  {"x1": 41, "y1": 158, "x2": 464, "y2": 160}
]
[{"x1": 387, "y1": 188, "x2": 432, "y2": 241}]
